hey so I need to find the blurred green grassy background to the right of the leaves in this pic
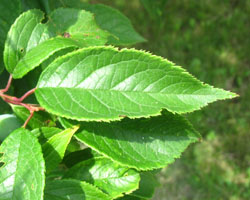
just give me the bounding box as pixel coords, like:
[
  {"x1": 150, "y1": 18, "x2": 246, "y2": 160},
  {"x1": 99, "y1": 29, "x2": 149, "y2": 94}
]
[{"x1": 96, "y1": 0, "x2": 250, "y2": 200}]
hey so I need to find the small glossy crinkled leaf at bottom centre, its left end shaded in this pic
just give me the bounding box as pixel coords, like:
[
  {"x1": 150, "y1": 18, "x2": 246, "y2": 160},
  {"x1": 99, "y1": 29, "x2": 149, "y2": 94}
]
[{"x1": 65, "y1": 158, "x2": 140, "y2": 198}]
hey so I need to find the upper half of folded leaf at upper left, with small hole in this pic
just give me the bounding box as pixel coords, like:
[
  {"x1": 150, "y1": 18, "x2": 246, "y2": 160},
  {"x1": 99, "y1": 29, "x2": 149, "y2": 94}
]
[{"x1": 4, "y1": 9, "x2": 49, "y2": 73}]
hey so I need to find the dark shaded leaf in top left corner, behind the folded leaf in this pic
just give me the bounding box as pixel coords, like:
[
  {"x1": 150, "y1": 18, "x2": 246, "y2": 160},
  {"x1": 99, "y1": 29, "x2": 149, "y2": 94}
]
[{"x1": 0, "y1": 0, "x2": 21, "y2": 74}]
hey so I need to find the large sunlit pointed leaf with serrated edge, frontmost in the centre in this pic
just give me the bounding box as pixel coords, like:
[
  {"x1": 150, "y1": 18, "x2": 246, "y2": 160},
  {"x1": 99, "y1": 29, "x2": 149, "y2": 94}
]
[{"x1": 36, "y1": 47, "x2": 236, "y2": 121}]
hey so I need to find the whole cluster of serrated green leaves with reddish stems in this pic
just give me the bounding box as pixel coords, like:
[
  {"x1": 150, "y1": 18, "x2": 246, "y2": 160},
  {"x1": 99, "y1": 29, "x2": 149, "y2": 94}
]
[{"x1": 0, "y1": 0, "x2": 236, "y2": 200}]
